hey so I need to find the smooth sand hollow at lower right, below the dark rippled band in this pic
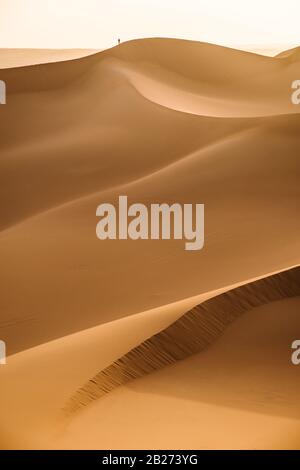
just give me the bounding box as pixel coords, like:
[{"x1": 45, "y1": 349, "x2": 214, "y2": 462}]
[{"x1": 56, "y1": 297, "x2": 300, "y2": 449}]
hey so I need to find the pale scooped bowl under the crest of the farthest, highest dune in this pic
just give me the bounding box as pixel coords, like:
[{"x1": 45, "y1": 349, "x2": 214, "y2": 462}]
[{"x1": 106, "y1": 39, "x2": 299, "y2": 117}]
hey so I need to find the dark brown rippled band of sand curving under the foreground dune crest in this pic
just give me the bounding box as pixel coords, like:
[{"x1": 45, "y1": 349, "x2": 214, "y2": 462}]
[{"x1": 65, "y1": 267, "x2": 300, "y2": 413}]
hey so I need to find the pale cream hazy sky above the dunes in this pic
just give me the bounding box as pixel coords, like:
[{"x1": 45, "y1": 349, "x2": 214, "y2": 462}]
[{"x1": 0, "y1": 0, "x2": 300, "y2": 49}]
